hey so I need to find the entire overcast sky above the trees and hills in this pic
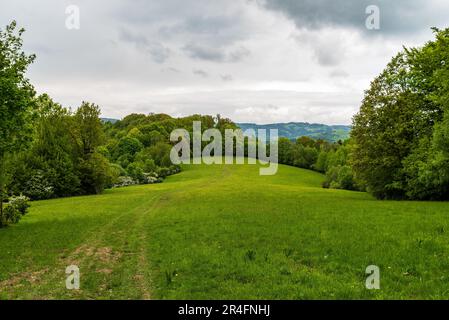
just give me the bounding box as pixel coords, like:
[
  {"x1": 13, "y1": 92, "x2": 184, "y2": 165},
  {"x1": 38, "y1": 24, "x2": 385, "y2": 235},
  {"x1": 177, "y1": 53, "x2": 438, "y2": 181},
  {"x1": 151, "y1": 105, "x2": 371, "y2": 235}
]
[{"x1": 0, "y1": 0, "x2": 449, "y2": 124}]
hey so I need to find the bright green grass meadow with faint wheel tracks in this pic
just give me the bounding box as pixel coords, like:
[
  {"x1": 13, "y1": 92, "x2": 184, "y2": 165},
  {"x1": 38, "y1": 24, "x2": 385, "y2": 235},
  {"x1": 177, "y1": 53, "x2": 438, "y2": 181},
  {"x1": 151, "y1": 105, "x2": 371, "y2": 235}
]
[{"x1": 0, "y1": 165, "x2": 449, "y2": 299}]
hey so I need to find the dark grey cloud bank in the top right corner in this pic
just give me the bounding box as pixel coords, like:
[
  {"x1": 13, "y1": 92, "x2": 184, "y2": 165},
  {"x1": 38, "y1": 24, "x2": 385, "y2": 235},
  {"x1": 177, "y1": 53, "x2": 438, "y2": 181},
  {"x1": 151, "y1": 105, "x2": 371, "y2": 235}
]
[{"x1": 258, "y1": 0, "x2": 449, "y2": 35}]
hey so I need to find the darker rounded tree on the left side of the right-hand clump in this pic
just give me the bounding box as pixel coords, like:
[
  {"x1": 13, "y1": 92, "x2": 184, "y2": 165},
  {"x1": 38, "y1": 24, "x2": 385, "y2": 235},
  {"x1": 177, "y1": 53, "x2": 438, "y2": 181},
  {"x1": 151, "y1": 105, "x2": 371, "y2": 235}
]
[{"x1": 351, "y1": 53, "x2": 421, "y2": 198}]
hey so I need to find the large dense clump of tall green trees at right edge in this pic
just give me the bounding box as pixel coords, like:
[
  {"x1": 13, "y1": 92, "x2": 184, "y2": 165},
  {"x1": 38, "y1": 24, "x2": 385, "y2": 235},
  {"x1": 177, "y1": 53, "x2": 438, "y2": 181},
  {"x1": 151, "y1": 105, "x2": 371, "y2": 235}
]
[{"x1": 351, "y1": 29, "x2": 449, "y2": 200}]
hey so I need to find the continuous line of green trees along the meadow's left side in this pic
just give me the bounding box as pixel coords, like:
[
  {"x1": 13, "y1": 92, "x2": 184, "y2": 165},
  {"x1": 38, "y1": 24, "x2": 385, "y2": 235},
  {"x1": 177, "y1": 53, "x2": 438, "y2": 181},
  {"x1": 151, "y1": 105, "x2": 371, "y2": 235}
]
[{"x1": 0, "y1": 22, "x2": 236, "y2": 226}]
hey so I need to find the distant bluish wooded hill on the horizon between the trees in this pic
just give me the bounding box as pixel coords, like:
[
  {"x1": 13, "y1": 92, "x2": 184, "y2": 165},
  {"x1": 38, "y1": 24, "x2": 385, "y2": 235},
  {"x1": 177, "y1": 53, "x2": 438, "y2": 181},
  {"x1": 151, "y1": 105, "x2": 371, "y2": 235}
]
[{"x1": 237, "y1": 122, "x2": 351, "y2": 142}]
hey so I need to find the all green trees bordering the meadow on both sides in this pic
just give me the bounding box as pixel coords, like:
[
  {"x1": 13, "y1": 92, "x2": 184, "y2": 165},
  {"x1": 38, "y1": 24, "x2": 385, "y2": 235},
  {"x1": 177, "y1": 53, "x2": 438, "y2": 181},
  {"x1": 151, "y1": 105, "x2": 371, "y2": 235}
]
[{"x1": 0, "y1": 22, "x2": 449, "y2": 225}]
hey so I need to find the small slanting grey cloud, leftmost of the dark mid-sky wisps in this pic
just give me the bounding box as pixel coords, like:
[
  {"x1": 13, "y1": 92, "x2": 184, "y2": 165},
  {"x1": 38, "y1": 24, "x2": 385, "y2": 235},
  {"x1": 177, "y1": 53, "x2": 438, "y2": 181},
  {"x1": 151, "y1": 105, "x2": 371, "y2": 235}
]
[{"x1": 120, "y1": 30, "x2": 170, "y2": 63}]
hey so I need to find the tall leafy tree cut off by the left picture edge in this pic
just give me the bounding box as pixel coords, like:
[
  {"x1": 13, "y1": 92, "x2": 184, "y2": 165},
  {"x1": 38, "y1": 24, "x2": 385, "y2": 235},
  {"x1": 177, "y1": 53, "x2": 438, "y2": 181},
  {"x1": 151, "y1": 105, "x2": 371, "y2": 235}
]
[{"x1": 0, "y1": 21, "x2": 35, "y2": 226}]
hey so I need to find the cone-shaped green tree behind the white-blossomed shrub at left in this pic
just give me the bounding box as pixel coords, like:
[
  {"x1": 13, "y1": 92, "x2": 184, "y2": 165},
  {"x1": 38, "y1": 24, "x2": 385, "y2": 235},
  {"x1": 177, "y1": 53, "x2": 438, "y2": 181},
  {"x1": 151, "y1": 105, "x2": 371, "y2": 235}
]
[{"x1": 11, "y1": 94, "x2": 79, "y2": 199}]
